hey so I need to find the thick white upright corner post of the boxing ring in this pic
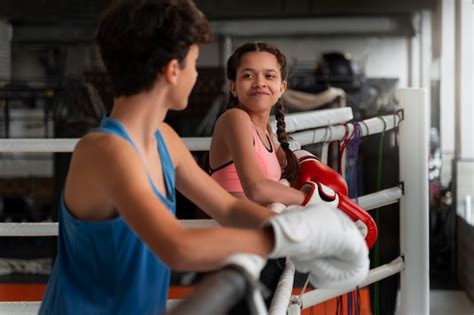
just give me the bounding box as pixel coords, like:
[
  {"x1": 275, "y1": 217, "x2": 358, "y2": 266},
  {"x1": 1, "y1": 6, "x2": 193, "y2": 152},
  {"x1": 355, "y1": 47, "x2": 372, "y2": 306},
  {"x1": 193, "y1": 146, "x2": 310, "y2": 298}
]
[{"x1": 399, "y1": 89, "x2": 430, "y2": 314}]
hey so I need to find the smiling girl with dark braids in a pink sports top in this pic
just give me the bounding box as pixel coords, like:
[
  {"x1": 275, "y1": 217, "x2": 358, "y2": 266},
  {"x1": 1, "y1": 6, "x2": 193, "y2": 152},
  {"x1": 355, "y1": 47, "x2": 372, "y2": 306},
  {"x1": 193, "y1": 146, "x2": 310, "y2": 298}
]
[{"x1": 208, "y1": 42, "x2": 306, "y2": 314}]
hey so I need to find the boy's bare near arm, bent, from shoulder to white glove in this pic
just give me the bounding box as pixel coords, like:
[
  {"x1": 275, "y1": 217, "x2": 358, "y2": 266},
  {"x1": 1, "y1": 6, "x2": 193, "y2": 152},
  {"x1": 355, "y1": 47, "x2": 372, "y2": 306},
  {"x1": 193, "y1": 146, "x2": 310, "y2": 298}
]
[{"x1": 88, "y1": 132, "x2": 273, "y2": 271}]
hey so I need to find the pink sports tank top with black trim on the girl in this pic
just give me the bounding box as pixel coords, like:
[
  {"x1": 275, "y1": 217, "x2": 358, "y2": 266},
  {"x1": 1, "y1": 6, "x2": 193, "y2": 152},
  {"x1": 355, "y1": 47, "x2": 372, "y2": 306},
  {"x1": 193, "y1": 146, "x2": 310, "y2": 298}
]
[{"x1": 210, "y1": 124, "x2": 281, "y2": 192}]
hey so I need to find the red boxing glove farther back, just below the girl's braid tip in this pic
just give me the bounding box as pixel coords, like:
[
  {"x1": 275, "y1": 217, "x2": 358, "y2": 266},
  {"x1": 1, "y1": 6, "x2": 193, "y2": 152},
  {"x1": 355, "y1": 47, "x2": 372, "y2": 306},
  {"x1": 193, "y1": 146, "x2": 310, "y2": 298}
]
[{"x1": 293, "y1": 150, "x2": 348, "y2": 196}]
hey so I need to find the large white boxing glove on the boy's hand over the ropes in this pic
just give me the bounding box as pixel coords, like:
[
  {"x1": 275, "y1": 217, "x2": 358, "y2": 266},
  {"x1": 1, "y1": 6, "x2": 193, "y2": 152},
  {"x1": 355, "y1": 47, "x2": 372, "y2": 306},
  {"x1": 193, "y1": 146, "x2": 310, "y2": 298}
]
[{"x1": 267, "y1": 205, "x2": 369, "y2": 288}]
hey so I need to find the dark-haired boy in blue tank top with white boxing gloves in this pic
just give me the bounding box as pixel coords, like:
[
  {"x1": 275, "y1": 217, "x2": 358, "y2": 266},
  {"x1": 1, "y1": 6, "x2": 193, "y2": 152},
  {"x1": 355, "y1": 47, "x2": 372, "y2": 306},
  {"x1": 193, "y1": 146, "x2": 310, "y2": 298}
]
[{"x1": 40, "y1": 0, "x2": 370, "y2": 314}]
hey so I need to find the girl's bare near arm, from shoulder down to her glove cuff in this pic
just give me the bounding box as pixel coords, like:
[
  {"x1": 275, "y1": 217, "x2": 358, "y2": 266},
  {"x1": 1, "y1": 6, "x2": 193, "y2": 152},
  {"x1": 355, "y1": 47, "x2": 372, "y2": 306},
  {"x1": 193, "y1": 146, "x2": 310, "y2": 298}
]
[{"x1": 214, "y1": 110, "x2": 305, "y2": 205}]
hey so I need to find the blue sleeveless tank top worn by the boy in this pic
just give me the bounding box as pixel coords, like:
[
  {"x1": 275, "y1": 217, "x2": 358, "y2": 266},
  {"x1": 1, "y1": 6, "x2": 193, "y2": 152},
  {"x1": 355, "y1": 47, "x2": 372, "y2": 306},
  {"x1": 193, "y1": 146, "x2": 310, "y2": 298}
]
[{"x1": 39, "y1": 118, "x2": 176, "y2": 315}]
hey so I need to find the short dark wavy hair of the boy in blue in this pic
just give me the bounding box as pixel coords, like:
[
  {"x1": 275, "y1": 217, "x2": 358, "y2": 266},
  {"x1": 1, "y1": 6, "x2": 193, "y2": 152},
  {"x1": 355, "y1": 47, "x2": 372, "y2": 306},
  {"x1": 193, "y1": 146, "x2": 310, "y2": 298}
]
[{"x1": 96, "y1": 0, "x2": 212, "y2": 97}]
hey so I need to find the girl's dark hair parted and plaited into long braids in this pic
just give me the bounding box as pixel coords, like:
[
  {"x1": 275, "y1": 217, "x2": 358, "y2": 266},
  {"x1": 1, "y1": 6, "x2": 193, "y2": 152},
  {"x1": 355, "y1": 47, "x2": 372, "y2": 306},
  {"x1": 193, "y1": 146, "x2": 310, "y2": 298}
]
[{"x1": 226, "y1": 42, "x2": 299, "y2": 185}]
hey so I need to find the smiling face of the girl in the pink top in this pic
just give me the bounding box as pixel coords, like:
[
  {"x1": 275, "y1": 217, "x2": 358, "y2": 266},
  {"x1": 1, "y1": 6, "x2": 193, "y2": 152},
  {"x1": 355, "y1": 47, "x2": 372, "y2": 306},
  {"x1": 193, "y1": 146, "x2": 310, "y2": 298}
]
[{"x1": 230, "y1": 51, "x2": 287, "y2": 112}]
